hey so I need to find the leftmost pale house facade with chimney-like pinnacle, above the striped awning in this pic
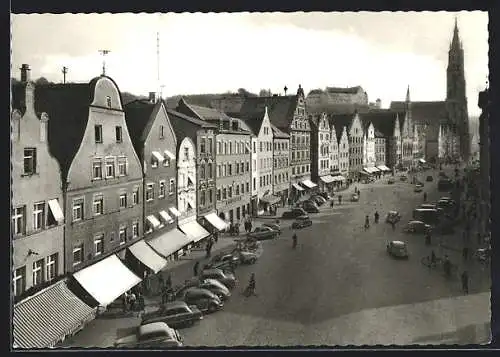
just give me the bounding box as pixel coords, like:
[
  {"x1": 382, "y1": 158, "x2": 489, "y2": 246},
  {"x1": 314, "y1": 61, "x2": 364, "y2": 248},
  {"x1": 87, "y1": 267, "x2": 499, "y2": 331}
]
[{"x1": 11, "y1": 65, "x2": 65, "y2": 301}]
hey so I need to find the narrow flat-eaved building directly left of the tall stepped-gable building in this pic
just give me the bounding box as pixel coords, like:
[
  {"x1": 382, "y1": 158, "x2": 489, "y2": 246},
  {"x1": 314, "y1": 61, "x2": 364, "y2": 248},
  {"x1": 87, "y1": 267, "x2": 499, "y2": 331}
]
[{"x1": 272, "y1": 125, "x2": 290, "y2": 205}]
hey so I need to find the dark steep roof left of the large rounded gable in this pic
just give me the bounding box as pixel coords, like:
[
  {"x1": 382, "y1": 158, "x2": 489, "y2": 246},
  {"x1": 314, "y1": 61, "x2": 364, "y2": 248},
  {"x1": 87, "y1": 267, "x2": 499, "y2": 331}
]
[{"x1": 35, "y1": 77, "x2": 99, "y2": 182}]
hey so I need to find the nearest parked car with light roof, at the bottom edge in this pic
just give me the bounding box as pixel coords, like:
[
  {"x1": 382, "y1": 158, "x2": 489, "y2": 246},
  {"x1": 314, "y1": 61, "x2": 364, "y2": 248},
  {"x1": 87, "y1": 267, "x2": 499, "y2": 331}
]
[{"x1": 114, "y1": 322, "x2": 182, "y2": 348}]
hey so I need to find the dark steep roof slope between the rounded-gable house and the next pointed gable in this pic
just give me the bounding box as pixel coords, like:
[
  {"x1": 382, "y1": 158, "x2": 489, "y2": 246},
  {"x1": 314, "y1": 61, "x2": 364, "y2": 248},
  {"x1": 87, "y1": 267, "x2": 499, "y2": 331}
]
[{"x1": 123, "y1": 100, "x2": 160, "y2": 154}]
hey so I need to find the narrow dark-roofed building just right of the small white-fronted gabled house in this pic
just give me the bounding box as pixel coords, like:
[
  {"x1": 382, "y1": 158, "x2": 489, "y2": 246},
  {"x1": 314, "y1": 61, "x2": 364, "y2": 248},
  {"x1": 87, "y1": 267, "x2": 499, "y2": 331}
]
[{"x1": 167, "y1": 109, "x2": 227, "y2": 232}]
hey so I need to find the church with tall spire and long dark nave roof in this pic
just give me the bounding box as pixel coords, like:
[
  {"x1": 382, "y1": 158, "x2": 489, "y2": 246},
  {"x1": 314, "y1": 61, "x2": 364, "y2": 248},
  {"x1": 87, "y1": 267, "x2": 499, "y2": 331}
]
[{"x1": 391, "y1": 19, "x2": 470, "y2": 161}]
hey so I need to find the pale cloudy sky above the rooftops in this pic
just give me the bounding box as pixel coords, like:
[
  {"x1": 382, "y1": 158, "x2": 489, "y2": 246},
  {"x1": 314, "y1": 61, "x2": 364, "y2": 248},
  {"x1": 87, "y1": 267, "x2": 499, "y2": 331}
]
[{"x1": 11, "y1": 11, "x2": 489, "y2": 115}]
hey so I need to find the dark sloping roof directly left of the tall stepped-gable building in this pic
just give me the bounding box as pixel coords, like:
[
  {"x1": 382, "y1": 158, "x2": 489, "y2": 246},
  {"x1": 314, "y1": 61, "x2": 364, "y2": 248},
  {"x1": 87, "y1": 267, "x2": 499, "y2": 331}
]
[{"x1": 233, "y1": 95, "x2": 298, "y2": 132}]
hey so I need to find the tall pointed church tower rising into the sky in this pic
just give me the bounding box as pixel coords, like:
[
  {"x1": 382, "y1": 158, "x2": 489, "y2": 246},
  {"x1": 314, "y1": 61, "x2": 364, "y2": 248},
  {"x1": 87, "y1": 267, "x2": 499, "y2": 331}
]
[{"x1": 446, "y1": 18, "x2": 470, "y2": 160}]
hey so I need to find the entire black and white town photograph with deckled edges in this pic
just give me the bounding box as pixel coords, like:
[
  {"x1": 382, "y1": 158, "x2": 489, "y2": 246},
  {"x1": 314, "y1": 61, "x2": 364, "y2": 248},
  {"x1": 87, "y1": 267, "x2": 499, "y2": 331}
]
[{"x1": 10, "y1": 11, "x2": 492, "y2": 350}]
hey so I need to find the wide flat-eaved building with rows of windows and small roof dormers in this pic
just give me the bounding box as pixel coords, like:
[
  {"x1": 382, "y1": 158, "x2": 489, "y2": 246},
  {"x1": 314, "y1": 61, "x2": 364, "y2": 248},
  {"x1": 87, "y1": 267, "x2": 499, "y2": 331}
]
[{"x1": 176, "y1": 99, "x2": 252, "y2": 223}]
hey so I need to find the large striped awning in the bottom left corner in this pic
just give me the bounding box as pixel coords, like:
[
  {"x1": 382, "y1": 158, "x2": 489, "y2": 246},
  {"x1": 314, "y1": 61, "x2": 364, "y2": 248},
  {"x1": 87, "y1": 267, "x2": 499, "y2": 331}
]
[{"x1": 13, "y1": 280, "x2": 95, "y2": 348}]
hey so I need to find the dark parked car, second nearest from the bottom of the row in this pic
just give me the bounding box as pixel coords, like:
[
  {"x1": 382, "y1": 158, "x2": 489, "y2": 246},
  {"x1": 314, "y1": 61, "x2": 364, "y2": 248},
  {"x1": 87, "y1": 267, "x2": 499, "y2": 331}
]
[{"x1": 141, "y1": 301, "x2": 203, "y2": 328}]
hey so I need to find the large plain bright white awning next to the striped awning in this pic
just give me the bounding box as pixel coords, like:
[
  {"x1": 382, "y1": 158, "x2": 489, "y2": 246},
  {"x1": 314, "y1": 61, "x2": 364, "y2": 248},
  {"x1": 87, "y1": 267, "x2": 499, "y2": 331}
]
[{"x1": 73, "y1": 254, "x2": 141, "y2": 306}]
